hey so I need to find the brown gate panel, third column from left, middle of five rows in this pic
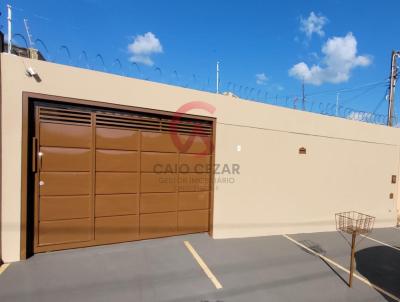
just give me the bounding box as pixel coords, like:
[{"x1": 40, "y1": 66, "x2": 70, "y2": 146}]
[{"x1": 140, "y1": 173, "x2": 177, "y2": 193}]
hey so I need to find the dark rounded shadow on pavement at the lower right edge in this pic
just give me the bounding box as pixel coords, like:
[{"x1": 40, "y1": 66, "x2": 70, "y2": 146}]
[{"x1": 355, "y1": 246, "x2": 400, "y2": 301}]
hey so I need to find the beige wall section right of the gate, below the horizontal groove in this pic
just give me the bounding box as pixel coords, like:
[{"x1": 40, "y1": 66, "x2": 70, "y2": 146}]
[{"x1": 215, "y1": 125, "x2": 399, "y2": 238}]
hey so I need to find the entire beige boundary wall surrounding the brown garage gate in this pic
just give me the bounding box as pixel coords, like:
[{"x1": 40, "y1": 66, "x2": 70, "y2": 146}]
[{"x1": 1, "y1": 54, "x2": 400, "y2": 262}]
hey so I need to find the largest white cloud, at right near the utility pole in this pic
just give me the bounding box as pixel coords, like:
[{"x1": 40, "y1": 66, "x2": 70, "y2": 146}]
[{"x1": 289, "y1": 32, "x2": 371, "y2": 85}]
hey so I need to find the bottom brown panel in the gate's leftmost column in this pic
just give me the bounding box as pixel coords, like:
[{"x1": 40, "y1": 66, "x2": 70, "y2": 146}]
[{"x1": 39, "y1": 219, "x2": 92, "y2": 245}]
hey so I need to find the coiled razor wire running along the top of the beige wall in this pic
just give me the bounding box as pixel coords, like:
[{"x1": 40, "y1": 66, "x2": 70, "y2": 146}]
[{"x1": 6, "y1": 33, "x2": 394, "y2": 127}]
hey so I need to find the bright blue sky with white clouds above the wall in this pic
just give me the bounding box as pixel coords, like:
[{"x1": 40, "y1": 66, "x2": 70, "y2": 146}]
[{"x1": 0, "y1": 0, "x2": 400, "y2": 117}]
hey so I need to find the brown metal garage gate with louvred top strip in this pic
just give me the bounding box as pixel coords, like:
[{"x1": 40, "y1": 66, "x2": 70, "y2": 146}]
[{"x1": 33, "y1": 104, "x2": 212, "y2": 252}]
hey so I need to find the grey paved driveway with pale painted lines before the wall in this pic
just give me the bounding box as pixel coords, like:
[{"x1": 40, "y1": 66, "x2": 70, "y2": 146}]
[{"x1": 0, "y1": 228, "x2": 400, "y2": 302}]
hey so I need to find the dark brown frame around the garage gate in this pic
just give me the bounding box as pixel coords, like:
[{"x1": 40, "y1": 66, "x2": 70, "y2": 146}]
[{"x1": 21, "y1": 91, "x2": 216, "y2": 259}]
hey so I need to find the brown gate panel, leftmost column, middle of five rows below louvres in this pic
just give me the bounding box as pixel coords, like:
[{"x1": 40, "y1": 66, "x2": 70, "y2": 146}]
[{"x1": 39, "y1": 172, "x2": 91, "y2": 196}]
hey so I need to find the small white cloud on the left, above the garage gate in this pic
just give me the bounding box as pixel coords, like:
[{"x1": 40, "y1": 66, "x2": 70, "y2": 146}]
[{"x1": 128, "y1": 32, "x2": 163, "y2": 66}]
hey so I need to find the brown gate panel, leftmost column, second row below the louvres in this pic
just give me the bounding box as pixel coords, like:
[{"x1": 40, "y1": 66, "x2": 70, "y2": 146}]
[{"x1": 40, "y1": 147, "x2": 92, "y2": 172}]
